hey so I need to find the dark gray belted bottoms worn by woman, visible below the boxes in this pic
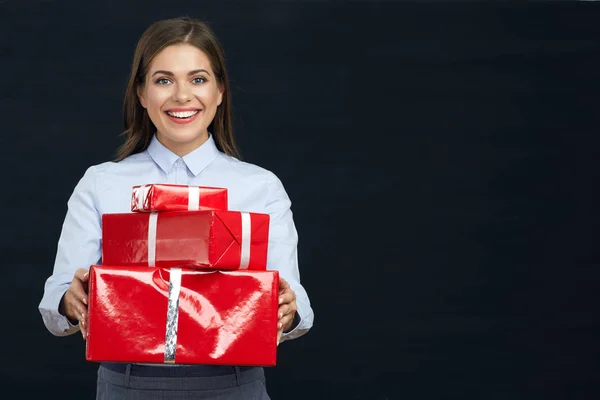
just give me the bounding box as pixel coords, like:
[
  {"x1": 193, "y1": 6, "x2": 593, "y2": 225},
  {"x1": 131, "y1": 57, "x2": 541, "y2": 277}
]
[{"x1": 96, "y1": 364, "x2": 270, "y2": 400}]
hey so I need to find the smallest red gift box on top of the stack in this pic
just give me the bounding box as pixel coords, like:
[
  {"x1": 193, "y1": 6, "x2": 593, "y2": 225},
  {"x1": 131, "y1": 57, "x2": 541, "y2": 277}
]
[{"x1": 131, "y1": 184, "x2": 228, "y2": 212}]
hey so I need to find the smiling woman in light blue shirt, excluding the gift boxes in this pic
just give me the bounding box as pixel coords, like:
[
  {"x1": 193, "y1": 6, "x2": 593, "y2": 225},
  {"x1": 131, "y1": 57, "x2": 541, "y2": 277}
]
[{"x1": 39, "y1": 18, "x2": 313, "y2": 399}]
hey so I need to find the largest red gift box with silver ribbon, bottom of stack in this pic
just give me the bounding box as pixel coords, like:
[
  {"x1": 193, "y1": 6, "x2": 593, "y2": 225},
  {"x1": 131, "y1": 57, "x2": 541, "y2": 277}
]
[{"x1": 86, "y1": 265, "x2": 279, "y2": 366}]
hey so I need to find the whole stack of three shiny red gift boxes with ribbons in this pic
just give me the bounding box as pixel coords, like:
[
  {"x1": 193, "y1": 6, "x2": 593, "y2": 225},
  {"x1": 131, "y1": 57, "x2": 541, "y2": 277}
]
[{"x1": 86, "y1": 184, "x2": 279, "y2": 366}]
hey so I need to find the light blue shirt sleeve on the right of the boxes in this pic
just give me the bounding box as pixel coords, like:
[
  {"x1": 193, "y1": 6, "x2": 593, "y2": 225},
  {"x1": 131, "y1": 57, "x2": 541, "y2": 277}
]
[{"x1": 266, "y1": 173, "x2": 314, "y2": 342}]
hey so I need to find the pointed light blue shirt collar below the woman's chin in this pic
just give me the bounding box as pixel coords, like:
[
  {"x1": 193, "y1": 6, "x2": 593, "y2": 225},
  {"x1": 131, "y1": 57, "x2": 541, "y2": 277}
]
[{"x1": 146, "y1": 133, "x2": 219, "y2": 176}]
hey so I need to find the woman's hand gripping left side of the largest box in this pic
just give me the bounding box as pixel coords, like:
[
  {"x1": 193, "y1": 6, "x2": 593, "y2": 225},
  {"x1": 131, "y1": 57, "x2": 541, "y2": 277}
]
[{"x1": 58, "y1": 268, "x2": 90, "y2": 340}]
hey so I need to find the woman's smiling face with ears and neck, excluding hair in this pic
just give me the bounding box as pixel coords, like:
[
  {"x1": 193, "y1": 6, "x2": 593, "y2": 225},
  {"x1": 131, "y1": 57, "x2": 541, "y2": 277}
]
[{"x1": 138, "y1": 44, "x2": 223, "y2": 157}]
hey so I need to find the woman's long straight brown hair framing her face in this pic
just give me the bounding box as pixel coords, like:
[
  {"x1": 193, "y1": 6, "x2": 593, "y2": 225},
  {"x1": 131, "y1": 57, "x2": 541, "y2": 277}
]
[{"x1": 116, "y1": 17, "x2": 240, "y2": 161}]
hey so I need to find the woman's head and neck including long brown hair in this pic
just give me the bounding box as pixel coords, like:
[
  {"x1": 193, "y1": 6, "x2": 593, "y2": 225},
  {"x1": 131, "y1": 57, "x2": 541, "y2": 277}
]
[{"x1": 117, "y1": 19, "x2": 239, "y2": 160}]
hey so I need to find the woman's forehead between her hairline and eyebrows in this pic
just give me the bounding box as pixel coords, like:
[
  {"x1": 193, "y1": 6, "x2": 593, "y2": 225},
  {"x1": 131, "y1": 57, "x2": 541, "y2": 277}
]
[{"x1": 150, "y1": 44, "x2": 212, "y2": 73}]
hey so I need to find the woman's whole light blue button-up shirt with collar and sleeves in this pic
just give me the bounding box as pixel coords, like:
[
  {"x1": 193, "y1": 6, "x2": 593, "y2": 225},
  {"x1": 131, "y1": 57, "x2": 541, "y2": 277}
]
[{"x1": 39, "y1": 135, "x2": 313, "y2": 342}]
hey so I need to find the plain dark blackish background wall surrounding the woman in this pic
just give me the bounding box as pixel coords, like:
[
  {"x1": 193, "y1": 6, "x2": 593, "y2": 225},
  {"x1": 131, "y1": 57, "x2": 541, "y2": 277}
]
[{"x1": 0, "y1": 0, "x2": 600, "y2": 400}]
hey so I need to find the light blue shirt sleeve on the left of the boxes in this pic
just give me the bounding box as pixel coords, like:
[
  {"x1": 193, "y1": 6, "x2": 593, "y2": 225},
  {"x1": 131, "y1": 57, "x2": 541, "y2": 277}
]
[{"x1": 38, "y1": 167, "x2": 102, "y2": 336}]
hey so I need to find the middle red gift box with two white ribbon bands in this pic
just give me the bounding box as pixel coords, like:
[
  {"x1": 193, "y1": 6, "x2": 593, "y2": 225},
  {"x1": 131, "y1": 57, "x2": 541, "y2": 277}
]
[{"x1": 102, "y1": 211, "x2": 269, "y2": 271}]
